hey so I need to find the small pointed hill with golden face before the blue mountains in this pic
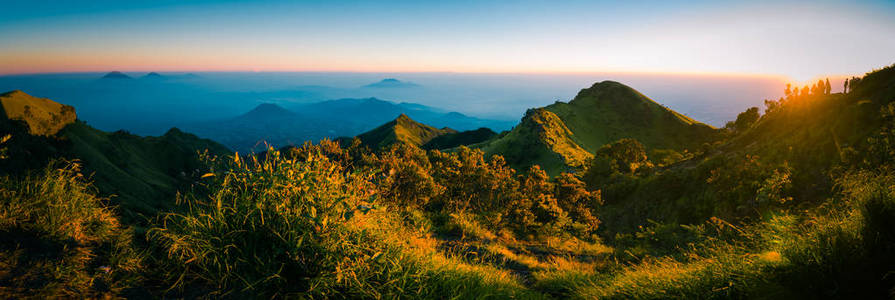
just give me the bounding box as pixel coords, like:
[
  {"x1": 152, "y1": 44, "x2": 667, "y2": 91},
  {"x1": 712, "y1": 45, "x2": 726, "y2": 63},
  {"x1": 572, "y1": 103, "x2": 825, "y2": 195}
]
[{"x1": 357, "y1": 114, "x2": 457, "y2": 148}]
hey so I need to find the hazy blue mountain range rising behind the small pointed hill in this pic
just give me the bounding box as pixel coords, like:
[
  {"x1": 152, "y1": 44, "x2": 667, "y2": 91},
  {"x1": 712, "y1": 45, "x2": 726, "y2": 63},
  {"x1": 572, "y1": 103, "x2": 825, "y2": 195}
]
[{"x1": 181, "y1": 98, "x2": 512, "y2": 152}]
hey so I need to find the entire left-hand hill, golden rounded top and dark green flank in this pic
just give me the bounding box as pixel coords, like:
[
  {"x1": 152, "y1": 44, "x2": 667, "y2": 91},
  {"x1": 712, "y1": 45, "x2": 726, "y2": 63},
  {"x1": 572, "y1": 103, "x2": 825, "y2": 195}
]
[{"x1": 0, "y1": 91, "x2": 229, "y2": 221}]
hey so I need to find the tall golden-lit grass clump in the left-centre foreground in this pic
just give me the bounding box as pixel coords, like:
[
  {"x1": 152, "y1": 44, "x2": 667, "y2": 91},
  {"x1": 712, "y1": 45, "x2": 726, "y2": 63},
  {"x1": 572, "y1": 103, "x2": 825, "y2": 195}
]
[{"x1": 150, "y1": 151, "x2": 534, "y2": 298}]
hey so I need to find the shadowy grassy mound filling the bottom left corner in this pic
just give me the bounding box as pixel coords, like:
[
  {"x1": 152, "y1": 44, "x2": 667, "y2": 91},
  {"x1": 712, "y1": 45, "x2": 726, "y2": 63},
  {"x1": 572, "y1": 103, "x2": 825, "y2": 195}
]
[{"x1": 0, "y1": 162, "x2": 142, "y2": 298}]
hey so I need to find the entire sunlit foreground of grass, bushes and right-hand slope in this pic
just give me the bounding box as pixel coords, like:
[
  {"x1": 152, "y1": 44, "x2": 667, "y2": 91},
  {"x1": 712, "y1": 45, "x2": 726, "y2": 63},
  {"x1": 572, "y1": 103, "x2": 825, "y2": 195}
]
[{"x1": 0, "y1": 67, "x2": 895, "y2": 299}]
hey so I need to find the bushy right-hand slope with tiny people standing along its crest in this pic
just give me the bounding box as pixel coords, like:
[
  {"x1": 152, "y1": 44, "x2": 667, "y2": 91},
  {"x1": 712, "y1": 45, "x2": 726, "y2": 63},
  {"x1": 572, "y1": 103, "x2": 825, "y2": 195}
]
[{"x1": 598, "y1": 67, "x2": 895, "y2": 229}]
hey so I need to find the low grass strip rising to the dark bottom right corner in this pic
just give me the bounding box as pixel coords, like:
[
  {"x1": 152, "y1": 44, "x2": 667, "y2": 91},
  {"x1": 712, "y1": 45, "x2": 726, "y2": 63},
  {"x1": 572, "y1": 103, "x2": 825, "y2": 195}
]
[{"x1": 538, "y1": 173, "x2": 895, "y2": 299}]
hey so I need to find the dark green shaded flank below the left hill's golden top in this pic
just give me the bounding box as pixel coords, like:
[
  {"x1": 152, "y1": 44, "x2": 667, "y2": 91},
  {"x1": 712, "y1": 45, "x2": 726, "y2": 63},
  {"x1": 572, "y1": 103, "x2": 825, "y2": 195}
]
[{"x1": 60, "y1": 122, "x2": 230, "y2": 218}]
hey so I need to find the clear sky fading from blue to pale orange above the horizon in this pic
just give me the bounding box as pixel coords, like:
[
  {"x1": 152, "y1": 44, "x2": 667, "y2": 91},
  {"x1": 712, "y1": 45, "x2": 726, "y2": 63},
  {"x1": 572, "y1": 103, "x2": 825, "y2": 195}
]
[{"x1": 0, "y1": 0, "x2": 895, "y2": 82}]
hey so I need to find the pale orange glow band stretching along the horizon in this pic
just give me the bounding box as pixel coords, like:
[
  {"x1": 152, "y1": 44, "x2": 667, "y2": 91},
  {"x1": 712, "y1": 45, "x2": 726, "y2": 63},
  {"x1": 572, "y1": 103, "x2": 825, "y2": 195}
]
[{"x1": 0, "y1": 52, "x2": 800, "y2": 82}]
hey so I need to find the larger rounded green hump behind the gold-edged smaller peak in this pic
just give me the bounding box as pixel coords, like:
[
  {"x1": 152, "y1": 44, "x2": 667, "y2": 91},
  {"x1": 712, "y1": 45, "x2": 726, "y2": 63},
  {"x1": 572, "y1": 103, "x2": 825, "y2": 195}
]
[{"x1": 545, "y1": 81, "x2": 714, "y2": 152}]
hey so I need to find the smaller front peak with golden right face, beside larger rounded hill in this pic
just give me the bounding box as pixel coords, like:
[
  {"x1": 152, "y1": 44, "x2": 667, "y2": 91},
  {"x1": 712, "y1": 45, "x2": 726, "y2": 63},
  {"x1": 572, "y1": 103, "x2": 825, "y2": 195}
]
[{"x1": 477, "y1": 108, "x2": 593, "y2": 174}]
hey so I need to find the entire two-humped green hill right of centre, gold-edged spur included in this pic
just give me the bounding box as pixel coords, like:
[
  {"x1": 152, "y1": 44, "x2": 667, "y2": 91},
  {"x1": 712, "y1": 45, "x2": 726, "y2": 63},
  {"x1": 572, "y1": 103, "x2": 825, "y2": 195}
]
[{"x1": 474, "y1": 81, "x2": 717, "y2": 175}]
